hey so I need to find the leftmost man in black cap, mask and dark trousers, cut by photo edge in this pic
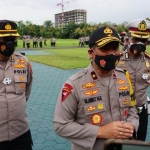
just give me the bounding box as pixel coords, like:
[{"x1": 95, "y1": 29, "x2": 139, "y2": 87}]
[{"x1": 0, "y1": 20, "x2": 32, "y2": 150}]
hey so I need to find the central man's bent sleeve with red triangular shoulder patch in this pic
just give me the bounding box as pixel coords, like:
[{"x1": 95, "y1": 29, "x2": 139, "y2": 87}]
[{"x1": 53, "y1": 80, "x2": 99, "y2": 150}]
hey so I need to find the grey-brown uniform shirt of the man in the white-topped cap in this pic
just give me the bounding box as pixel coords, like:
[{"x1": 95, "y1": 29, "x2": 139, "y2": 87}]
[{"x1": 118, "y1": 50, "x2": 150, "y2": 107}]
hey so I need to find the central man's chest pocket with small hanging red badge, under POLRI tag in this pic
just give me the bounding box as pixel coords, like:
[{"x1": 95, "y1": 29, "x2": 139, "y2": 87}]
[{"x1": 119, "y1": 96, "x2": 130, "y2": 121}]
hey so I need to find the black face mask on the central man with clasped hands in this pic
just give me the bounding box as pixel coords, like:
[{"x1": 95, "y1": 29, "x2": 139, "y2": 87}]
[{"x1": 95, "y1": 54, "x2": 121, "y2": 71}]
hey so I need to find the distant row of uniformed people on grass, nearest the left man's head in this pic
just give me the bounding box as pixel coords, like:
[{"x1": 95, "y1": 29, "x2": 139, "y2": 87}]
[{"x1": 22, "y1": 36, "x2": 56, "y2": 48}]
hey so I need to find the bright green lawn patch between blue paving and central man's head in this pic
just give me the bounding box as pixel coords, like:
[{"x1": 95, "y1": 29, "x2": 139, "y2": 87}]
[{"x1": 27, "y1": 48, "x2": 90, "y2": 69}]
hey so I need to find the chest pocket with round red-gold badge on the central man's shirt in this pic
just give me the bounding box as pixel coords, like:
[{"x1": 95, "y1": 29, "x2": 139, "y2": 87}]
[{"x1": 84, "y1": 101, "x2": 107, "y2": 126}]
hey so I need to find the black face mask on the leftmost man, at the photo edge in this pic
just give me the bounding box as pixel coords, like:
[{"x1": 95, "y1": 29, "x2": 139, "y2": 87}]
[{"x1": 0, "y1": 41, "x2": 16, "y2": 57}]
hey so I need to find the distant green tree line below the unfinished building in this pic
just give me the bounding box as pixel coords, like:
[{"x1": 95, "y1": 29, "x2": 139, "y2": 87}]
[{"x1": 17, "y1": 18, "x2": 150, "y2": 39}]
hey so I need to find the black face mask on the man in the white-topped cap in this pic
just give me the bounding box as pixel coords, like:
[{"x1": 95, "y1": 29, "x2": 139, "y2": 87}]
[{"x1": 130, "y1": 43, "x2": 146, "y2": 56}]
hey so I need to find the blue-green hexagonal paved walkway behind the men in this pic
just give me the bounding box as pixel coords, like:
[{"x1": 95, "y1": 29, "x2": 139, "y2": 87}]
[{"x1": 21, "y1": 51, "x2": 150, "y2": 150}]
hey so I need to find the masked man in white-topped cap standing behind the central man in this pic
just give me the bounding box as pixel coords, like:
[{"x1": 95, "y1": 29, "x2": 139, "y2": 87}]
[{"x1": 118, "y1": 19, "x2": 150, "y2": 141}]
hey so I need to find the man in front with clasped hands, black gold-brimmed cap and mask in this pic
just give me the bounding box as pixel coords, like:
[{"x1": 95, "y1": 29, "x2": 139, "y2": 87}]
[{"x1": 54, "y1": 26, "x2": 139, "y2": 150}]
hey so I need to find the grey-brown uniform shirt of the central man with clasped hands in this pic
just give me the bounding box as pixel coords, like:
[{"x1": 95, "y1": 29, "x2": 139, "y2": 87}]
[{"x1": 54, "y1": 64, "x2": 139, "y2": 150}]
